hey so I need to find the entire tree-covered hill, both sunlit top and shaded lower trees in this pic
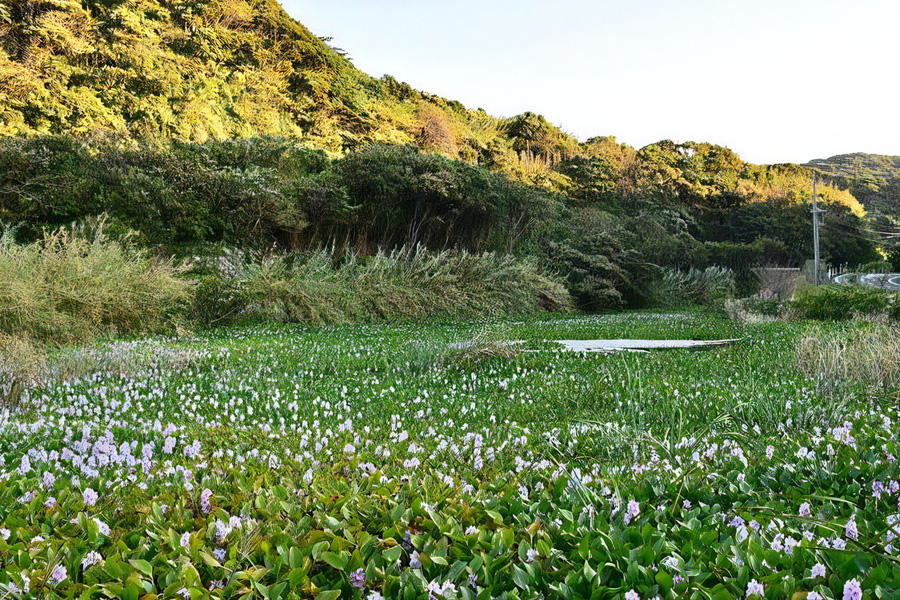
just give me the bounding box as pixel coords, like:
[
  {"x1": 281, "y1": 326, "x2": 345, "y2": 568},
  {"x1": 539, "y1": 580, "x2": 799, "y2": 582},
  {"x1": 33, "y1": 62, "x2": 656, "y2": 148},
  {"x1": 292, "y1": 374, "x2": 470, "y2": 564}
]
[{"x1": 0, "y1": 0, "x2": 900, "y2": 308}]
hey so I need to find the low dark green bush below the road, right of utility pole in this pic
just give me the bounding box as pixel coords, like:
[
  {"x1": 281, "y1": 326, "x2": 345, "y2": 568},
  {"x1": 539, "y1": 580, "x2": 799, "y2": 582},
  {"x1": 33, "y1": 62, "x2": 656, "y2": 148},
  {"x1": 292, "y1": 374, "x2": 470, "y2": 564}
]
[{"x1": 791, "y1": 285, "x2": 892, "y2": 321}]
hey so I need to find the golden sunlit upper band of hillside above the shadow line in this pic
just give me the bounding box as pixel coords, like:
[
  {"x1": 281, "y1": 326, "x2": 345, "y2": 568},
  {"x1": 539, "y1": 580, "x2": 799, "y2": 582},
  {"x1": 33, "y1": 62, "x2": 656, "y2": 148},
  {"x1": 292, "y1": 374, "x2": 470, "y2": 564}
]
[{"x1": 0, "y1": 0, "x2": 880, "y2": 223}]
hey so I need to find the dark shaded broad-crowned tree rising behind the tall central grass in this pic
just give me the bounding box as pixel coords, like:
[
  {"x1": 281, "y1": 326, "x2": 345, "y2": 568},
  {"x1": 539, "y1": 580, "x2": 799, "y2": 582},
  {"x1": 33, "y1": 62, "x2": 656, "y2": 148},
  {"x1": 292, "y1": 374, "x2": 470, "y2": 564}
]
[{"x1": 335, "y1": 145, "x2": 557, "y2": 251}]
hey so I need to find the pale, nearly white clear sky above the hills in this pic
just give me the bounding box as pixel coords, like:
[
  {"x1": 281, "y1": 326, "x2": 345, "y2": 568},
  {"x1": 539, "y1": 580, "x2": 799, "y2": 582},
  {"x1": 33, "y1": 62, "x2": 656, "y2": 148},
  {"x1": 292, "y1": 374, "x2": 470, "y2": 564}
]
[{"x1": 282, "y1": 0, "x2": 900, "y2": 163}]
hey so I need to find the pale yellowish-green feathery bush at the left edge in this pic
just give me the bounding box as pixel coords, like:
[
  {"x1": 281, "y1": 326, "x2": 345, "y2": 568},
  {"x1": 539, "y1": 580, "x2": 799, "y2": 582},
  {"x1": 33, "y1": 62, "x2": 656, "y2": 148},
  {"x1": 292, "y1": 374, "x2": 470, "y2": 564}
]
[{"x1": 0, "y1": 225, "x2": 189, "y2": 342}]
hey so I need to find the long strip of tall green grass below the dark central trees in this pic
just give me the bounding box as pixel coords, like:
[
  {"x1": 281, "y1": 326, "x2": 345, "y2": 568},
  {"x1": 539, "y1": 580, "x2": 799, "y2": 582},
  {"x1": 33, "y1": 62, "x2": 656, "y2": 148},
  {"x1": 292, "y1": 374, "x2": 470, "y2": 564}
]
[{"x1": 195, "y1": 248, "x2": 570, "y2": 324}]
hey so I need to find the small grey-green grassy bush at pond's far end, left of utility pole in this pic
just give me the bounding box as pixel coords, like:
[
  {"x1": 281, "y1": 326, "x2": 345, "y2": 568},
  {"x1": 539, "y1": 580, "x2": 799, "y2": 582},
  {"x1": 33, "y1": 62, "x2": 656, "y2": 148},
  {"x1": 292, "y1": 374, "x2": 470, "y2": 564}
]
[{"x1": 652, "y1": 267, "x2": 735, "y2": 306}]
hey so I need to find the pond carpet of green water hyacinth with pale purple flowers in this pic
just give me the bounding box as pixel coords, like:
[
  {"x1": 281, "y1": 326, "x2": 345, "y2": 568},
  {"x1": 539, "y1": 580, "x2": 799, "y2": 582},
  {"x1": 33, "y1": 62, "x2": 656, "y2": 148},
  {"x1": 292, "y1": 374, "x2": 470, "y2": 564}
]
[{"x1": 0, "y1": 313, "x2": 900, "y2": 600}]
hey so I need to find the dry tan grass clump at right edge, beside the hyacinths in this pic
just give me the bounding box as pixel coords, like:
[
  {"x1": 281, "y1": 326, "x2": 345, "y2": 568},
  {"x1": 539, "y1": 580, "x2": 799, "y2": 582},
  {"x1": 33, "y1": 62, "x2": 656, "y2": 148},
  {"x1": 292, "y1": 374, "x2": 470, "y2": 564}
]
[{"x1": 797, "y1": 319, "x2": 900, "y2": 394}]
